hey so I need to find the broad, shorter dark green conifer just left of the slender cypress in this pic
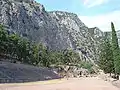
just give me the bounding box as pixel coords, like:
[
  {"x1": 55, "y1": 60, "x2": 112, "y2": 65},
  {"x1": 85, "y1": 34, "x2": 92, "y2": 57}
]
[{"x1": 99, "y1": 33, "x2": 114, "y2": 74}]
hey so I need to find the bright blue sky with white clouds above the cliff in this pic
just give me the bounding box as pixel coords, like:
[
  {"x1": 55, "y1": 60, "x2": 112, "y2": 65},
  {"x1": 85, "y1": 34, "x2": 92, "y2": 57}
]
[{"x1": 36, "y1": 0, "x2": 120, "y2": 31}]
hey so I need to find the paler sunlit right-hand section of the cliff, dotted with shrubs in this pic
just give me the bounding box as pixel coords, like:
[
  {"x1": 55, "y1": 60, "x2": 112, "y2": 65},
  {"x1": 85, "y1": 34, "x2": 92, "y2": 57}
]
[{"x1": 50, "y1": 11, "x2": 103, "y2": 61}]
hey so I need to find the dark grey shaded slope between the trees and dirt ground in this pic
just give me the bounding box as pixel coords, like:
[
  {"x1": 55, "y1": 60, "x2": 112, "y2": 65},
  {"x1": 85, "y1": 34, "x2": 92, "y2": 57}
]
[{"x1": 0, "y1": 62, "x2": 60, "y2": 83}]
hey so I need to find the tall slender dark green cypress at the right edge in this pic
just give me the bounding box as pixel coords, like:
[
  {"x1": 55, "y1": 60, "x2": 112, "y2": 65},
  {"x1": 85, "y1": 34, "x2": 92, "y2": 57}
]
[{"x1": 111, "y1": 22, "x2": 120, "y2": 79}]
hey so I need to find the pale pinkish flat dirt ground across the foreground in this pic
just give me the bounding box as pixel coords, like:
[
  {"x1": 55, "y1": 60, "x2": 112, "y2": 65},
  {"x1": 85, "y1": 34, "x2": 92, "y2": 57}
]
[{"x1": 0, "y1": 77, "x2": 120, "y2": 90}]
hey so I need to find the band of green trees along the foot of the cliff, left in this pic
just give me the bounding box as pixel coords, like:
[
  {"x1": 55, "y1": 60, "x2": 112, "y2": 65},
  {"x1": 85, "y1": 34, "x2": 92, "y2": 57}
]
[{"x1": 0, "y1": 25, "x2": 80, "y2": 67}]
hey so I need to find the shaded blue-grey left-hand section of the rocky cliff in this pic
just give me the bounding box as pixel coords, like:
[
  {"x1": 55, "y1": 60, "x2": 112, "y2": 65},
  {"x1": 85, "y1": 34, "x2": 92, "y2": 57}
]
[{"x1": 0, "y1": 0, "x2": 61, "y2": 49}]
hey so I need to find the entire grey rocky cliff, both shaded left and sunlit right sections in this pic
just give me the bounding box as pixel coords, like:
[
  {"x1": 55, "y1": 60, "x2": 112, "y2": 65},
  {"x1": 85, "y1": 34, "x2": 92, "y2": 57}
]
[{"x1": 0, "y1": 0, "x2": 103, "y2": 61}]
